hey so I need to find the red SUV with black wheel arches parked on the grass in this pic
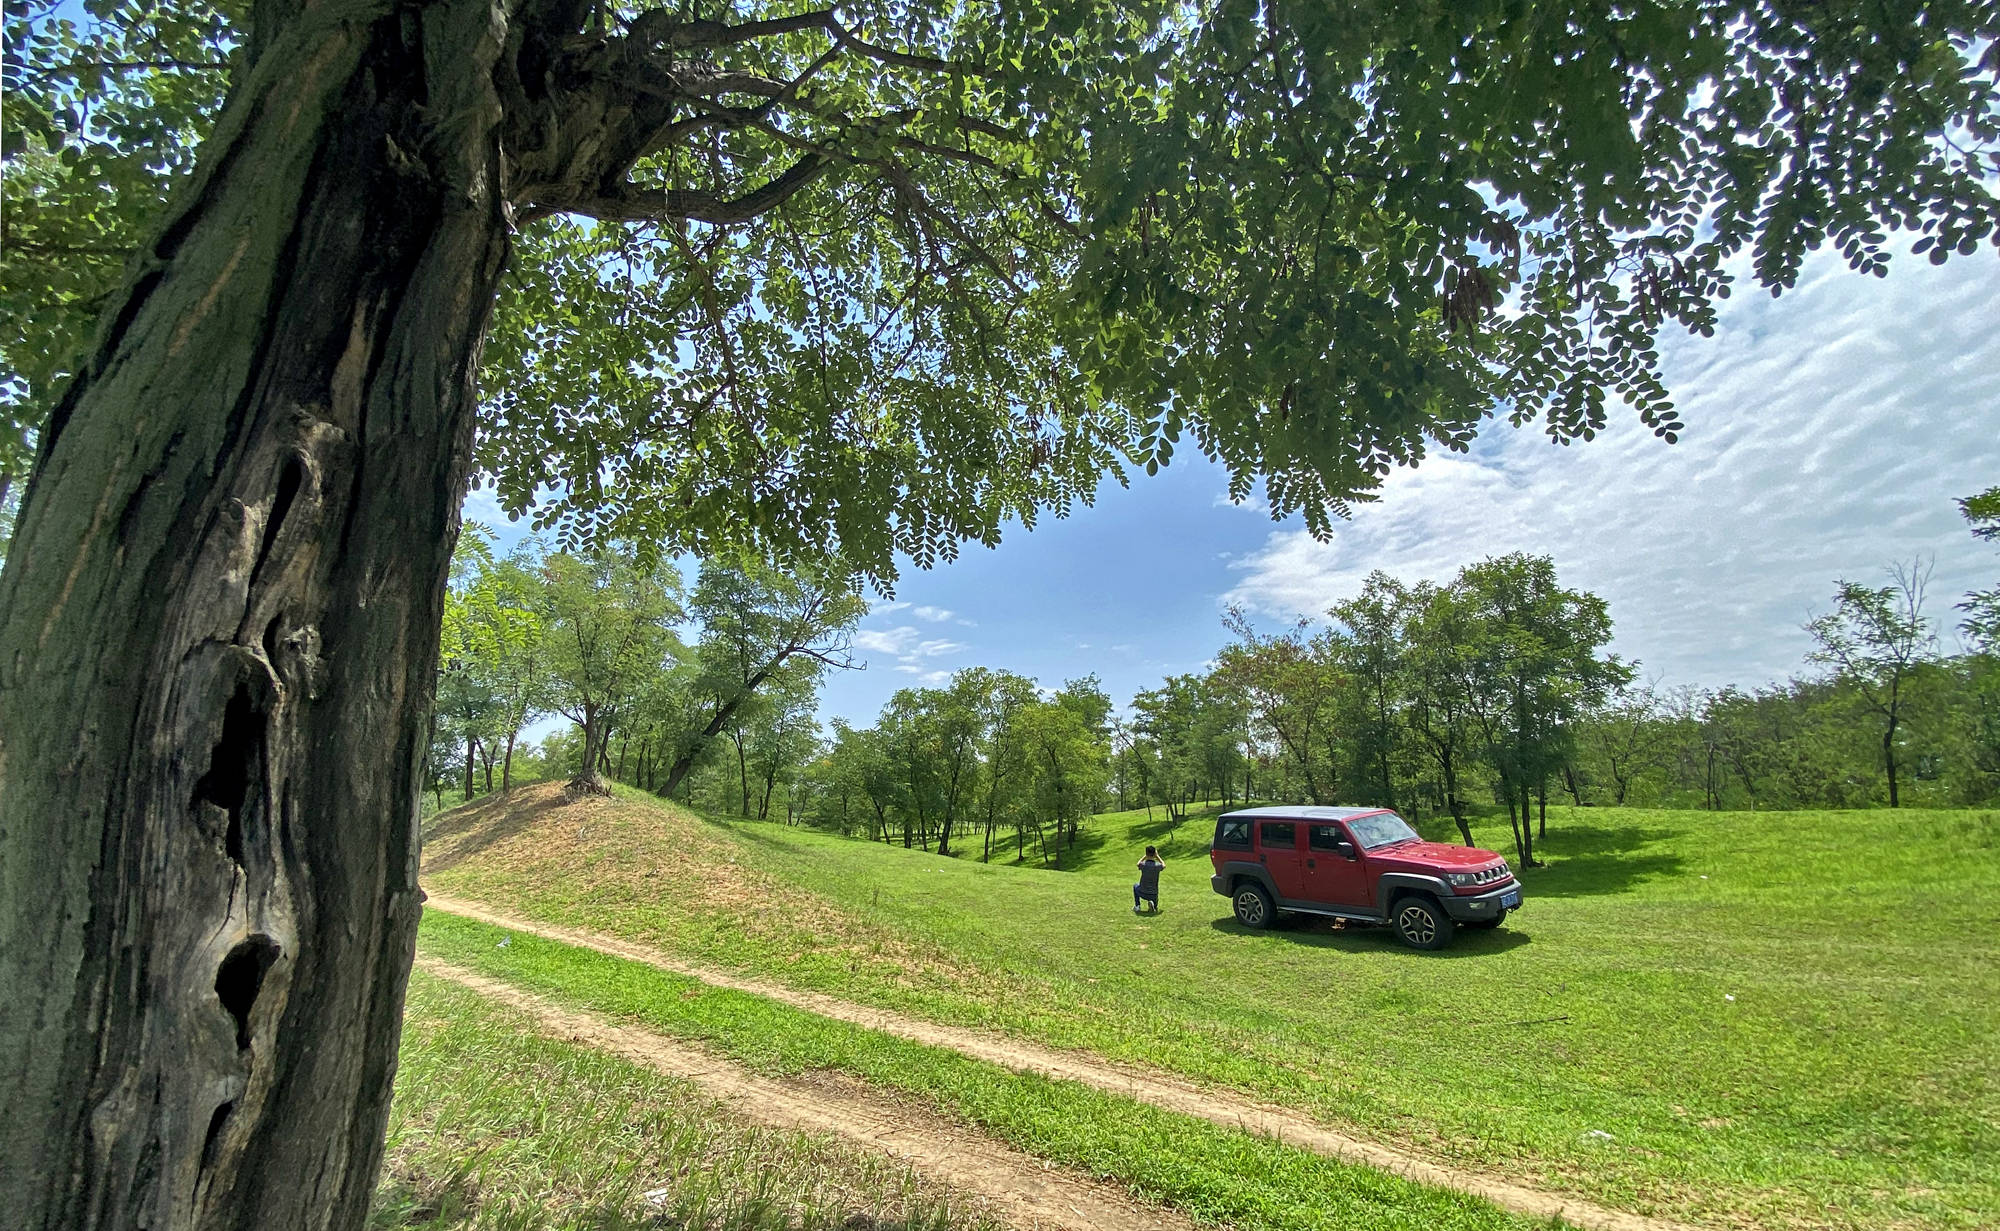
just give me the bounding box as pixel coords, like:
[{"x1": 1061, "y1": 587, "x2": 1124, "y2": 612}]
[{"x1": 1208, "y1": 807, "x2": 1520, "y2": 949}]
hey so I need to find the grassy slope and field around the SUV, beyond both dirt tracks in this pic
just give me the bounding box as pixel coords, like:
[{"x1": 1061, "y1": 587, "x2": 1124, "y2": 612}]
[{"x1": 426, "y1": 791, "x2": 2000, "y2": 1227}]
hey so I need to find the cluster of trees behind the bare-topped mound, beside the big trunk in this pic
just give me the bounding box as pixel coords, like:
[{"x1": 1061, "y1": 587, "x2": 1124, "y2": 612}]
[{"x1": 428, "y1": 526, "x2": 866, "y2": 815}]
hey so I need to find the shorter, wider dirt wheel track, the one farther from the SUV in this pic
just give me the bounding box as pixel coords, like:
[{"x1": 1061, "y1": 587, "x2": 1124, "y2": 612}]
[{"x1": 416, "y1": 957, "x2": 1194, "y2": 1231}]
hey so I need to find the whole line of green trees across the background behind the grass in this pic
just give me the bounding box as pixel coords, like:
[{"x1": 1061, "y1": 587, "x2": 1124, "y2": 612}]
[{"x1": 454, "y1": 492, "x2": 2000, "y2": 867}]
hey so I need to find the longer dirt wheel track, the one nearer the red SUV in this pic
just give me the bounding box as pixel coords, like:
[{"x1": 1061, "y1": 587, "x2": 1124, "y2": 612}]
[{"x1": 428, "y1": 893, "x2": 1692, "y2": 1231}]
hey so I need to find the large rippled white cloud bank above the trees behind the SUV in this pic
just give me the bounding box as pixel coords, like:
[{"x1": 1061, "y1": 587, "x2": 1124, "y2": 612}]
[{"x1": 1224, "y1": 249, "x2": 2000, "y2": 685}]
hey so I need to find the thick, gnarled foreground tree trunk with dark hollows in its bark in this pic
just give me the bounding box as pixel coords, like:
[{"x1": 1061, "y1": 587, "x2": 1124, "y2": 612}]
[{"x1": 0, "y1": 0, "x2": 508, "y2": 1231}]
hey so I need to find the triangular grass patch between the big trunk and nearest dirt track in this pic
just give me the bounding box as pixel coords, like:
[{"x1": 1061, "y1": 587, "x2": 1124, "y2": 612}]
[{"x1": 370, "y1": 971, "x2": 998, "y2": 1231}]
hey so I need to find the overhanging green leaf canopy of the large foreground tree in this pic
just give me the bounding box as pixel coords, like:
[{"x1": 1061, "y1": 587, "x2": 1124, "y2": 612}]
[{"x1": 0, "y1": 0, "x2": 2000, "y2": 584}]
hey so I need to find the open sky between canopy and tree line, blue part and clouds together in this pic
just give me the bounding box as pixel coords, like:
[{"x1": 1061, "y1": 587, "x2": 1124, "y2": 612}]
[{"x1": 468, "y1": 254, "x2": 2000, "y2": 723}]
